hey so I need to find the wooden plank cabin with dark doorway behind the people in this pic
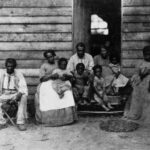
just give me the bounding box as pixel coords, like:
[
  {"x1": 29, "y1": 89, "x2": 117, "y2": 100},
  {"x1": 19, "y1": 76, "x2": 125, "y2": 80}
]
[{"x1": 0, "y1": 0, "x2": 150, "y2": 113}]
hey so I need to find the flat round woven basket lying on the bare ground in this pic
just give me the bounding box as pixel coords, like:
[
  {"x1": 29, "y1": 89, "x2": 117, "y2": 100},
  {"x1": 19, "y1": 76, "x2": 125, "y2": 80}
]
[{"x1": 100, "y1": 119, "x2": 139, "y2": 132}]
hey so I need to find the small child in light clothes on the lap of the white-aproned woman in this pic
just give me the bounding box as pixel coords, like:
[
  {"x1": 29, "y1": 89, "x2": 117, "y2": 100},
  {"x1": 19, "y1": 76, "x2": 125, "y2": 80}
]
[{"x1": 52, "y1": 58, "x2": 72, "y2": 98}]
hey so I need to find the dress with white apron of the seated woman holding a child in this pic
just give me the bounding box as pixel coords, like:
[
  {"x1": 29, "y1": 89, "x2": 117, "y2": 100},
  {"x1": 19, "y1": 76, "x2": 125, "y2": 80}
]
[{"x1": 35, "y1": 63, "x2": 77, "y2": 126}]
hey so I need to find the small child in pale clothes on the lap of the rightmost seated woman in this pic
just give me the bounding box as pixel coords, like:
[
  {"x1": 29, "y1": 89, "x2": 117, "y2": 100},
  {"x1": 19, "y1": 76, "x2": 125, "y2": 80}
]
[{"x1": 105, "y1": 54, "x2": 129, "y2": 95}]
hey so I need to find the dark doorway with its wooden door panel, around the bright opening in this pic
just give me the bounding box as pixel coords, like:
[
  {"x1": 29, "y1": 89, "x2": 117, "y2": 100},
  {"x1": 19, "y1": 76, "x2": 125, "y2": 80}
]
[{"x1": 73, "y1": 0, "x2": 121, "y2": 60}]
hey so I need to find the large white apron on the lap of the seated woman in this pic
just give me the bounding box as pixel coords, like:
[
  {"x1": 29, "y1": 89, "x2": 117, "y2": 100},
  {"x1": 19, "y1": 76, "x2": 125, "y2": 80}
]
[{"x1": 39, "y1": 80, "x2": 75, "y2": 111}]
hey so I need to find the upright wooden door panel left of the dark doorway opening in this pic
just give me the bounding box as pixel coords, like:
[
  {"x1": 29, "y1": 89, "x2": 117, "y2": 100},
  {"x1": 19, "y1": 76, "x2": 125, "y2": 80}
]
[{"x1": 73, "y1": 0, "x2": 91, "y2": 52}]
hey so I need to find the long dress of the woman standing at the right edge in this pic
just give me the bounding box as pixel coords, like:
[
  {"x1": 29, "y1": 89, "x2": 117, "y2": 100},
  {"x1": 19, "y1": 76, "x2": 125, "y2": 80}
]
[{"x1": 124, "y1": 61, "x2": 150, "y2": 125}]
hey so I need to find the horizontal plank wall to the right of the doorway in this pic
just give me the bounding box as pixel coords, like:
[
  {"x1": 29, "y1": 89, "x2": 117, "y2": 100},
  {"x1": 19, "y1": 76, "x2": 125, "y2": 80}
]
[{"x1": 122, "y1": 0, "x2": 150, "y2": 76}]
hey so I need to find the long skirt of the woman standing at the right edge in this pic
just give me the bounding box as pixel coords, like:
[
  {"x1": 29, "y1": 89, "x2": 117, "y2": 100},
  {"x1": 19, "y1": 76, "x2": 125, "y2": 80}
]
[{"x1": 124, "y1": 75, "x2": 150, "y2": 125}]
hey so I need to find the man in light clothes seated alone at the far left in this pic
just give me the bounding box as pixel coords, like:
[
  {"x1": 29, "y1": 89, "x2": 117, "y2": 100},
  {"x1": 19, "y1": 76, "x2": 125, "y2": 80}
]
[{"x1": 0, "y1": 58, "x2": 28, "y2": 131}]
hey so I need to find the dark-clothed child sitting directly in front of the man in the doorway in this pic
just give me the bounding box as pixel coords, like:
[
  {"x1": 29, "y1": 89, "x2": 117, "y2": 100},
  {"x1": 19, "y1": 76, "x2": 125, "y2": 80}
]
[{"x1": 73, "y1": 63, "x2": 90, "y2": 105}]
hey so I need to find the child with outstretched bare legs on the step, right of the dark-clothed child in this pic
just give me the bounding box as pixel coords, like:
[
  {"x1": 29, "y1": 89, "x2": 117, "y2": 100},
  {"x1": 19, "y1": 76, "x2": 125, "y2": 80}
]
[{"x1": 93, "y1": 65, "x2": 112, "y2": 111}]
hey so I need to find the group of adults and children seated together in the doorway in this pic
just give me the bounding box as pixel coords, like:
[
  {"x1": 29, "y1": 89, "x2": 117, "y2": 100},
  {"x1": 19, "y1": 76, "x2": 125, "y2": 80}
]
[{"x1": 66, "y1": 43, "x2": 129, "y2": 111}]
